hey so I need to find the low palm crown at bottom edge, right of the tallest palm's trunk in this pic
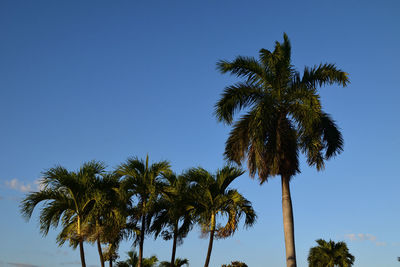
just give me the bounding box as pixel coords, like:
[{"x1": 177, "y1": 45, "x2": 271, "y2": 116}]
[{"x1": 307, "y1": 239, "x2": 355, "y2": 267}]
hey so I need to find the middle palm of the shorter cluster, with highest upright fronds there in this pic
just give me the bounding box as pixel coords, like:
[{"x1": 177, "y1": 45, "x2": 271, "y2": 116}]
[{"x1": 116, "y1": 156, "x2": 170, "y2": 267}]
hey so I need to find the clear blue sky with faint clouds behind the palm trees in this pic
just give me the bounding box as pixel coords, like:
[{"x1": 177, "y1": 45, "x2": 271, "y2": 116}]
[{"x1": 0, "y1": 0, "x2": 400, "y2": 267}]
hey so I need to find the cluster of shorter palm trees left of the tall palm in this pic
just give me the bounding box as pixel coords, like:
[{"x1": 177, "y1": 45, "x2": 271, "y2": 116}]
[{"x1": 21, "y1": 156, "x2": 256, "y2": 267}]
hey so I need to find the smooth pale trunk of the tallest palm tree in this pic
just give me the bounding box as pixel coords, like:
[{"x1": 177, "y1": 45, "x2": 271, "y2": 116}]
[{"x1": 281, "y1": 175, "x2": 297, "y2": 267}]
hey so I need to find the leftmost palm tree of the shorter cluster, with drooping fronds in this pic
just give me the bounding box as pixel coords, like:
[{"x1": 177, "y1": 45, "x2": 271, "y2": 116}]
[{"x1": 21, "y1": 161, "x2": 105, "y2": 267}]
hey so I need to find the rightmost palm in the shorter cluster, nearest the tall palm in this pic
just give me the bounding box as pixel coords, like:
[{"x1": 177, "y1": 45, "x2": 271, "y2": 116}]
[{"x1": 186, "y1": 166, "x2": 256, "y2": 267}]
